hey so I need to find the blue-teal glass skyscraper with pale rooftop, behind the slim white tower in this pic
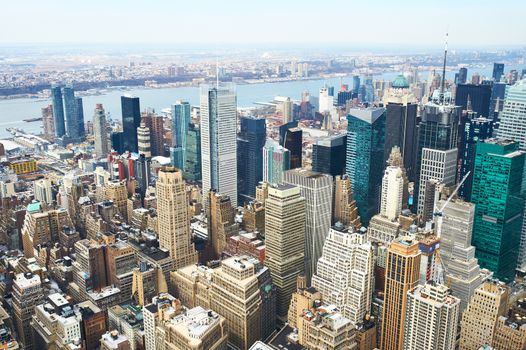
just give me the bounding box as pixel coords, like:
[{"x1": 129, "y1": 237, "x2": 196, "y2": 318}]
[{"x1": 346, "y1": 108, "x2": 387, "y2": 225}]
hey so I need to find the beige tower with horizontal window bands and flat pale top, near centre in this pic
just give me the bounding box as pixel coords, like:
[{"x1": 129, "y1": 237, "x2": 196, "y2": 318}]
[{"x1": 265, "y1": 184, "x2": 305, "y2": 318}]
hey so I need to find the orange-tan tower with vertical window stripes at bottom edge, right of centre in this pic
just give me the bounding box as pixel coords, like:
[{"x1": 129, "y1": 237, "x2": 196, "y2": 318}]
[{"x1": 380, "y1": 237, "x2": 421, "y2": 350}]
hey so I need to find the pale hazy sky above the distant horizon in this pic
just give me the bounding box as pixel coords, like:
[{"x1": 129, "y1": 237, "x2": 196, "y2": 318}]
[{"x1": 0, "y1": 0, "x2": 526, "y2": 49}]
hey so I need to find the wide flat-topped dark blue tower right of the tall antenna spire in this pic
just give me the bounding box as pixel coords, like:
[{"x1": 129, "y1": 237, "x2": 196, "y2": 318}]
[{"x1": 455, "y1": 84, "x2": 492, "y2": 117}]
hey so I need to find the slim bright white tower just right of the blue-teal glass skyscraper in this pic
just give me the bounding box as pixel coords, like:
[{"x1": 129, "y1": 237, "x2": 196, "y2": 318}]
[{"x1": 380, "y1": 166, "x2": 404, "y2": 221}]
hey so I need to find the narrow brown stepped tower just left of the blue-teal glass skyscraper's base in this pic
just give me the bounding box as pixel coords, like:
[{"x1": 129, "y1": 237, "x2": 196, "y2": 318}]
[{"x1": 332, "y1": 175, "x2": 362, "y2": 230}]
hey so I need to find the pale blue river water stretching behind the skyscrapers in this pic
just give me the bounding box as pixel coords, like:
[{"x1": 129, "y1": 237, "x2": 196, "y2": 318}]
[{"x1": 0, "y1": 66, "x2": 525, "y2": 138}]
